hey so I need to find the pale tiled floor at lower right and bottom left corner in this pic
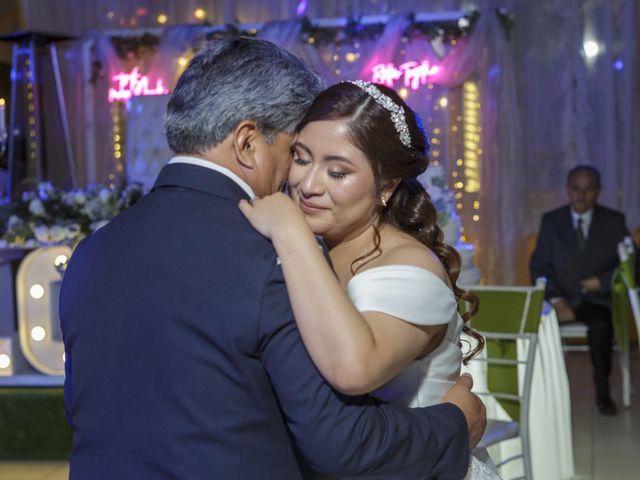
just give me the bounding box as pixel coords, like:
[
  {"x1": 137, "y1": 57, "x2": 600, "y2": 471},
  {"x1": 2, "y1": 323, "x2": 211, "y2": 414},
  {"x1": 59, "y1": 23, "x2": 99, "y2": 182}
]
[{"x1": 0, "y1": 349, "x2": 640, "y2": 480}]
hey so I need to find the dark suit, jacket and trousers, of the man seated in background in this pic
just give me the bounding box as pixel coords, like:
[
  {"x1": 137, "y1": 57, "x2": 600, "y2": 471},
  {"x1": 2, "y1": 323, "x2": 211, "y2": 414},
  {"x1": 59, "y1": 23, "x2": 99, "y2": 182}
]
[{"x1": 530, "y1": 205, "x2": 629, "y2": 400}]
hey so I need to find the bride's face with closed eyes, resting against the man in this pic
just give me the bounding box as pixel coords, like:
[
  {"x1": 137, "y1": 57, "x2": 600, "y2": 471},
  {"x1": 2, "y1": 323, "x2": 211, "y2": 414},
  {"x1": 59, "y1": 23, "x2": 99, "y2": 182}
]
[{"x1": 289, "y1": 120, "x2": 376, "y2": 246}]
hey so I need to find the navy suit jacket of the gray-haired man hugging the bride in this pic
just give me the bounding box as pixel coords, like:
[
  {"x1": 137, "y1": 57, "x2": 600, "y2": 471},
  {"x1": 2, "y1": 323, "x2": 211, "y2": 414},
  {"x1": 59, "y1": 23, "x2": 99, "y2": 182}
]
[{"x1": 60, "y1": 164, "x2": 469, "y2": 480}]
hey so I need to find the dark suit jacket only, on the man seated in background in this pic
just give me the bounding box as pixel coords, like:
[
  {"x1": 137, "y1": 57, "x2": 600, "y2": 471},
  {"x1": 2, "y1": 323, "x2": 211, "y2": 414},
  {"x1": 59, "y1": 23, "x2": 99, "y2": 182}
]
[{"x1": 530, "y1": 205, "x2": 629, "y2": 308}]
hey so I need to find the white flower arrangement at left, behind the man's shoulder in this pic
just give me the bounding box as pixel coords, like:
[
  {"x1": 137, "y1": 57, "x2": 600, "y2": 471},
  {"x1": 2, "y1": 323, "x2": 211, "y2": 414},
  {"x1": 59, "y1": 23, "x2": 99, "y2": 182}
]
[{"x1": 0, "y1": 182, "x2": 143, "y2": 248}]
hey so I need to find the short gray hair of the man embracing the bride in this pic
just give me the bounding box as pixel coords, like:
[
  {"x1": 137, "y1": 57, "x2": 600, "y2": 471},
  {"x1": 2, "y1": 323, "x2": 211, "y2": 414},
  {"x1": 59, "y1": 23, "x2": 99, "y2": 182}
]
[{"x1": 165, "y1": 37, "x2": 324, "y2": 154}]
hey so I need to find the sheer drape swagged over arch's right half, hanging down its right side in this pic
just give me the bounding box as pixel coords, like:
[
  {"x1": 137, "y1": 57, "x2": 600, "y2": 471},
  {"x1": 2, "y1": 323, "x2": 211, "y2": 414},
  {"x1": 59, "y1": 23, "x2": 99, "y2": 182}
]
[{"x1": 261, "y1": 10, "x2": 524, "y2": 284}]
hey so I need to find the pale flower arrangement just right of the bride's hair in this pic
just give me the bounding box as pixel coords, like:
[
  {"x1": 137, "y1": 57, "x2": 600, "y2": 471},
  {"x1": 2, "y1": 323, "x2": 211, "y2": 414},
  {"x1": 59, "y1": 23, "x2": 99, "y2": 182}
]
[{"x1": 418, "y1": 165, "x2": 460, "y2": 245}]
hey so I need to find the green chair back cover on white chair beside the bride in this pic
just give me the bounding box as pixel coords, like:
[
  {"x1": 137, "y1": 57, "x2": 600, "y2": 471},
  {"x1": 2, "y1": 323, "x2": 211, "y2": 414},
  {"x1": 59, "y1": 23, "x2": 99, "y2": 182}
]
[{"x1": 463, "y1": 286, "x2": 544, "y2": 420}]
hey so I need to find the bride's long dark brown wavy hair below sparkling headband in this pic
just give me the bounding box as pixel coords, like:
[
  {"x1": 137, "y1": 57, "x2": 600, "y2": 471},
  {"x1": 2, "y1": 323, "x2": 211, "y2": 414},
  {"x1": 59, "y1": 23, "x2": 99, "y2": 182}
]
[{"x1": 298, "y1": 82, "x2": 484, "y2": 363}]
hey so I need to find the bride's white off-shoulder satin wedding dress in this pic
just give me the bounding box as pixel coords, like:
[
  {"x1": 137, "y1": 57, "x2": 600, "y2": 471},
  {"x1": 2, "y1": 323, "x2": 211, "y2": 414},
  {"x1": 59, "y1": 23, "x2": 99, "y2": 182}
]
[{"x1": 347, "y1": 265, "x2": 500, "y2": 480}]
